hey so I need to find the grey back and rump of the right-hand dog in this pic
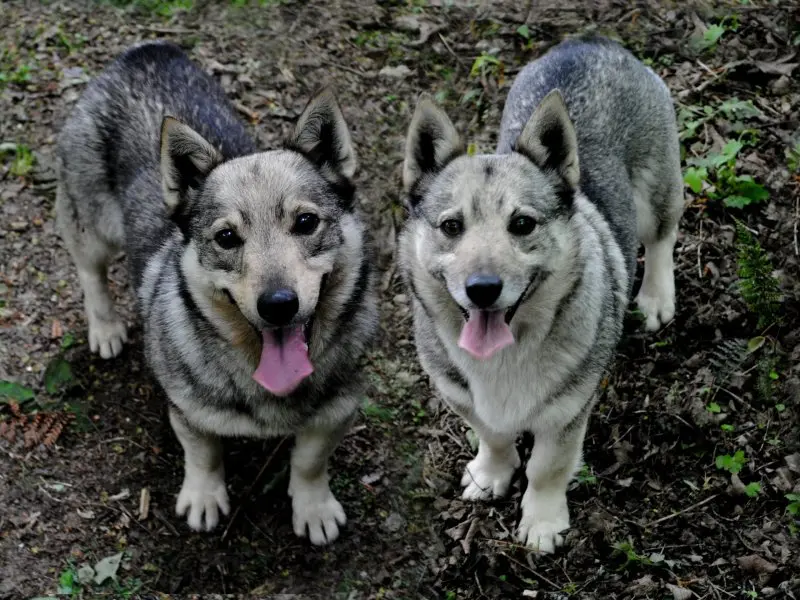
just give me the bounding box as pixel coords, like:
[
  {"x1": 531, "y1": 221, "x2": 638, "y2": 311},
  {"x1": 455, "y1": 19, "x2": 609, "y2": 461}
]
[{"x1": 497, "y1": 36, "x2": 682, "y2": 290}]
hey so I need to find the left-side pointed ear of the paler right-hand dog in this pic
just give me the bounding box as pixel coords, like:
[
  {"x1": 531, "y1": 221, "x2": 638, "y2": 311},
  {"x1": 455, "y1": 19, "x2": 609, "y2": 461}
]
[{"x1": 403, "y1": 94, "x2": 464, "y2": 193}]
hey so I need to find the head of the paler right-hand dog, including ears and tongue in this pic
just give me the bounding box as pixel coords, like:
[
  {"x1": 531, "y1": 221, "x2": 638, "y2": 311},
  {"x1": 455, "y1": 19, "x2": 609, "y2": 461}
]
[{"x1": 403, "y1": 90, "x2": 580, "y2": 358}]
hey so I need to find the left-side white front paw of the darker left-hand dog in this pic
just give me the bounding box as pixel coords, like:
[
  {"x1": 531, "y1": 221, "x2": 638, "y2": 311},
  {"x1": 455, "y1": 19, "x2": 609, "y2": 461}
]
[{"x1": 175, "y1": 468, "x2": 230, "y2": 531}]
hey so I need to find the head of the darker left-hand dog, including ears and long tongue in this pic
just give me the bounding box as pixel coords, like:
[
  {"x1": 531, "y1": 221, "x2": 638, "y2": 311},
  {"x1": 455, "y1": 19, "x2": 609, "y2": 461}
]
[{"x1": 161, "y1": 89, "x2": 360, "y2": 394}]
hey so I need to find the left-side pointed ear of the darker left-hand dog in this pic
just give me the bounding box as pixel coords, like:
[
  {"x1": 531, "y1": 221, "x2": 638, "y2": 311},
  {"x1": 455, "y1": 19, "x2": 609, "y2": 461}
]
[{"x1": 161, "y1": 116, "x2": 222, "y2": 216}]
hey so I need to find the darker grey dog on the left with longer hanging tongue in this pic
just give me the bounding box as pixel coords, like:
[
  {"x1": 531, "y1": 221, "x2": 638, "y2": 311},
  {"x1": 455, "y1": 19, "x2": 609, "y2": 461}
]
[{"x1": 56, "y1": 42, "x2": 378, "y2": 545}]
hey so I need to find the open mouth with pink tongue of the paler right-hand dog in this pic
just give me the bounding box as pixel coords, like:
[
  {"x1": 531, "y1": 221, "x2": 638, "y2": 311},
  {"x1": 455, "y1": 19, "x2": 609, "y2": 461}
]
[{"x1": 458, "y1": 273, "x2": 539, "y2": 360}]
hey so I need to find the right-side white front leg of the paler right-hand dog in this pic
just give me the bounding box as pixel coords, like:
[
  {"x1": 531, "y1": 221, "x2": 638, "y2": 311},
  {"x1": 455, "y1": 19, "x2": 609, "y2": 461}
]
[{"x1": 517, "y1": 410, "x2": 589, "y2": 552}]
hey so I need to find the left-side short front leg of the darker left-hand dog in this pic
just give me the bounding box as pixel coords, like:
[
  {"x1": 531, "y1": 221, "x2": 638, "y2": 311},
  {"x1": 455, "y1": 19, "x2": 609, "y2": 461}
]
[{"x1": 169, "y1": 407, "x2": 230, "y2": 531}]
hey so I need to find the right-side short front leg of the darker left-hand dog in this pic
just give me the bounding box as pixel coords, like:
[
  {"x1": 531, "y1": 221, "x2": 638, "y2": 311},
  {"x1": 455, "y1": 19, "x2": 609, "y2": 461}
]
[{"x1": 289, "y1": 419, "x2": 352, "y2": 546}]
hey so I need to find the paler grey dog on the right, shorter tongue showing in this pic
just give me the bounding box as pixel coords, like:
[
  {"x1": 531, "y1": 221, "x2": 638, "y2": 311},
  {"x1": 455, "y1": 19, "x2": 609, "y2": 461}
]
[{"x1": 399, "y1": 37, "x2": 684, "y2": 553}]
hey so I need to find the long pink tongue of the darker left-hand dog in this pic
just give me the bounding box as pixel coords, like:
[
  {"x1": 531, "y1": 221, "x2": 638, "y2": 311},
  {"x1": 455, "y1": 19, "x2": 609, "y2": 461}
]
[{"x1": 253, "y1": 326, "x2": 314, "y2": 396}]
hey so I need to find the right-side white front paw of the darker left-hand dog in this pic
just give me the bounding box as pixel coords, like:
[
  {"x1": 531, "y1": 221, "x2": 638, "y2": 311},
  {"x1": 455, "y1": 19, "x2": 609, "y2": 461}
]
[{"x1": 289, "y1": 477, "x2": 347, "y2": 546}]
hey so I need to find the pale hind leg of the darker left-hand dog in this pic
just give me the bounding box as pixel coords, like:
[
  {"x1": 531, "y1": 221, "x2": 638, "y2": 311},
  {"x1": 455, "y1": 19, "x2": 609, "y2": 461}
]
[{"x1": 56, "y1": 183, "x2": 128, "y2": 358}]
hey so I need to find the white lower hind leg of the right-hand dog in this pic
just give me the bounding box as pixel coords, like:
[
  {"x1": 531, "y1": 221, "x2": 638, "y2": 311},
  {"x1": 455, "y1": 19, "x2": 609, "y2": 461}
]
[{"x1": 636, "y1": 228, "x2": 678, "y2": 331}]
